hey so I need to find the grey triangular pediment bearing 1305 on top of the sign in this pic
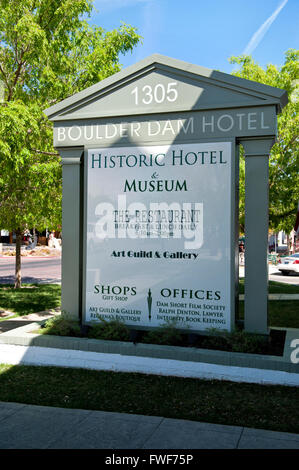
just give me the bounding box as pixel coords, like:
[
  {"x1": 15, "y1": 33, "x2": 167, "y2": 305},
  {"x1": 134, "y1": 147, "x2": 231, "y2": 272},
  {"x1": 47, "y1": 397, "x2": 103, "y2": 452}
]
[{"x1": 45, "y1": 54, "x2": 287, "y2": 121}]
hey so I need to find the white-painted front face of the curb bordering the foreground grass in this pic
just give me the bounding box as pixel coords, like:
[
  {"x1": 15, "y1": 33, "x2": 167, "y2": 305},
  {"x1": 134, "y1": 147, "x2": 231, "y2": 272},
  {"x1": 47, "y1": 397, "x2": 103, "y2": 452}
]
[{"x1": 0, "y1": 344, "x2": 299, "y2": 387}]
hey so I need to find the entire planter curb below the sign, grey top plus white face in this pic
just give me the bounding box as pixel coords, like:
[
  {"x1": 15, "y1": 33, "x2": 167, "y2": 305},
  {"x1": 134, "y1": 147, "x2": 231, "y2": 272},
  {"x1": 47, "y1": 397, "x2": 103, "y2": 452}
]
[{"x1": 0, "y1": 323, "x2": 299, "y2": 386}]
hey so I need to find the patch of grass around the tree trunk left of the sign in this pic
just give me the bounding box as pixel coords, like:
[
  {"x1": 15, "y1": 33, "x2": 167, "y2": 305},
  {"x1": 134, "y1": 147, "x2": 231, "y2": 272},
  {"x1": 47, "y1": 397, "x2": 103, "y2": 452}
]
[{"x1": 0, "y1": 284, "x2": 61, "y2": 316}]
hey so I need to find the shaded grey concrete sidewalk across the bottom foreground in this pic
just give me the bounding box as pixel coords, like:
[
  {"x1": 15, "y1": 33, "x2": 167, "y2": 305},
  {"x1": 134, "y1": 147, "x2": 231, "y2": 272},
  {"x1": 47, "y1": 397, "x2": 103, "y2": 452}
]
[{"x1": 0, "y1": 402, "x2": 299, "y2": 455}]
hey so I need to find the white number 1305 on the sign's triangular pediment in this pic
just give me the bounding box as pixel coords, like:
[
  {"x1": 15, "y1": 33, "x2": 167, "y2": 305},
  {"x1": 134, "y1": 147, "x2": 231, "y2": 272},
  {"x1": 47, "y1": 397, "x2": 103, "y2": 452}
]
[{"x1": 131, "y1": 82, "x2": 178, "y2": 106}]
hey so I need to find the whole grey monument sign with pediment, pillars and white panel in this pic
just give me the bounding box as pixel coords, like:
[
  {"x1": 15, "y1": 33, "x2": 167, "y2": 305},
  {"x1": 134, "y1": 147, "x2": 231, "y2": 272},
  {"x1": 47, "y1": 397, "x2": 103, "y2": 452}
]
[{"x1": 46, "y1": 55, "x2": 286, "y2": 334}]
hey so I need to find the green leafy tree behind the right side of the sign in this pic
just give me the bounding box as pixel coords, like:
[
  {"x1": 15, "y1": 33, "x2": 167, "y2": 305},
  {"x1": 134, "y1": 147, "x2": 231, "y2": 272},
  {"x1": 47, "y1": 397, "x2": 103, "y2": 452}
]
[{"x1": 230, "y1": 49, "x2": 299, "y2": 233}]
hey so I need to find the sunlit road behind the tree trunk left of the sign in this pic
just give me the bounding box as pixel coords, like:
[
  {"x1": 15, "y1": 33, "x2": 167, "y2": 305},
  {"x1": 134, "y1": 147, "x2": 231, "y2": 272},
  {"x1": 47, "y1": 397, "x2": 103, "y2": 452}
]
[{"x1": 0, "y1": 257, "x2": 61, "y2": 284}]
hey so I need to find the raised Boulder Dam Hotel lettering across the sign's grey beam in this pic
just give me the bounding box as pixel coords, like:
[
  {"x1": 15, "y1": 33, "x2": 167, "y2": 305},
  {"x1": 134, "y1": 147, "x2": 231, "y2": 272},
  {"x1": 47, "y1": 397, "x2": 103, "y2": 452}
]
[{"x1": 54, "y1": 110, "x2": 271, "y2": 144}]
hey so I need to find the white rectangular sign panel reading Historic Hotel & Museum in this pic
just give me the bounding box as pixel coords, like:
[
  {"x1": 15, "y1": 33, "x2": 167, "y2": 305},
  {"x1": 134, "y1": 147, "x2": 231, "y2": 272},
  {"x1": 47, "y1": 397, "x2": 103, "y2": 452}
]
[{"x1": 85, "y1": 142, "x2": 232, "y2": 331}]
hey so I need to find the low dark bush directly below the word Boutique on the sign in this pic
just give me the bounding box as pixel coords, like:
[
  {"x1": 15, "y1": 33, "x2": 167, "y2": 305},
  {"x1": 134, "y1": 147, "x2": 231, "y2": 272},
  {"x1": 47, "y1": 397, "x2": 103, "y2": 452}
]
[{"x1": 88, "y1": 320, "x2": 130, "y2": 341}]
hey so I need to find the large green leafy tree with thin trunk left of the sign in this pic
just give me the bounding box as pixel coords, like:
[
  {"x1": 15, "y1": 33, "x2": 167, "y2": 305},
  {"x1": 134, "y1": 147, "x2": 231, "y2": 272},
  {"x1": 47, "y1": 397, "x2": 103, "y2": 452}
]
[{"x1": 0, "y1": 0, "x2": 140, "y2": 287}]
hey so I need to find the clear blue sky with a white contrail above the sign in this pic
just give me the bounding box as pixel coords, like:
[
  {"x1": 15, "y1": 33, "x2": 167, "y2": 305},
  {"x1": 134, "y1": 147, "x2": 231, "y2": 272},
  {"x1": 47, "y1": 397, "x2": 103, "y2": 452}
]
[{"x1": 89, "y1": 0, "x2": 299, "y2": 73}]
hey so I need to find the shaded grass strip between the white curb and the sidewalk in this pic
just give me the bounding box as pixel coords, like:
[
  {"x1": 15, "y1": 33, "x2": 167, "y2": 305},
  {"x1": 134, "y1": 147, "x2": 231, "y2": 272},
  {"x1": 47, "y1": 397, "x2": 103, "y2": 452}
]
[{"x1": 0, "y1": 365, "x2": 299, "y2": 433}]
